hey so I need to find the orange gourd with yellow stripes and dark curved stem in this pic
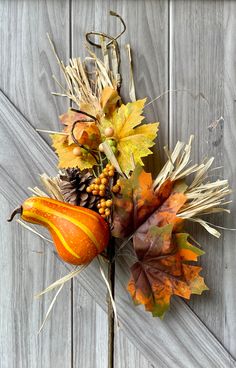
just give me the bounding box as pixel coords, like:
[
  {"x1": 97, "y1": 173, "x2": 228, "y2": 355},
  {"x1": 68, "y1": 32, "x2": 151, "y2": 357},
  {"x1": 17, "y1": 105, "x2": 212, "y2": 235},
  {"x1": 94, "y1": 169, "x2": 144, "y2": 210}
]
[{"x1": 9, "y1": 197, "x2": 109, "y2": 265}]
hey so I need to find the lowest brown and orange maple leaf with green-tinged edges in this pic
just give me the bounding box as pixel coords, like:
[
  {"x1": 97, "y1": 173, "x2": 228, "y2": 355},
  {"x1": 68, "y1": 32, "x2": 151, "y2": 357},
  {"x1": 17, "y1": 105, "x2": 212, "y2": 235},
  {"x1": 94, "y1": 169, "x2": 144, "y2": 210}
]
[{"x1": 128, "y1": 224, "x2": 208, "y2": 318}]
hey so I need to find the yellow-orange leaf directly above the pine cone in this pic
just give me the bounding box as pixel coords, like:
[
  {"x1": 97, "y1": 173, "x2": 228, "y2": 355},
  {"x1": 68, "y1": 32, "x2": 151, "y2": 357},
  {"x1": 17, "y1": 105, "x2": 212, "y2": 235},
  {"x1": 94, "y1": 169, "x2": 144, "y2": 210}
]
[{"x1": 51, "y1": 134, "x2": 96, "y2": 170}]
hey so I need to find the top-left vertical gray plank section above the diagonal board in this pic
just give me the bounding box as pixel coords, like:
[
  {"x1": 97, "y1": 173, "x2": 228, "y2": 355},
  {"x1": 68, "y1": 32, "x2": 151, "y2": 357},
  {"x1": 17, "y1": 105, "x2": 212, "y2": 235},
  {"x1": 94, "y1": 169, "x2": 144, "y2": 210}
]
[{"x1": 0, "y1": 0, "x2": 69, "y2": 142}]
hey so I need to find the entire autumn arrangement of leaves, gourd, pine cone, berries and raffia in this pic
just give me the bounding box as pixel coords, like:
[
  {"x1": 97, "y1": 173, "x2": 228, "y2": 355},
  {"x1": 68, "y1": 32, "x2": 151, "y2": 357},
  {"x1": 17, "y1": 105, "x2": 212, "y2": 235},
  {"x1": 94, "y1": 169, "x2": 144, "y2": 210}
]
[{"x1": 7, "y1": 12, "x2": 231, "y2": 328}]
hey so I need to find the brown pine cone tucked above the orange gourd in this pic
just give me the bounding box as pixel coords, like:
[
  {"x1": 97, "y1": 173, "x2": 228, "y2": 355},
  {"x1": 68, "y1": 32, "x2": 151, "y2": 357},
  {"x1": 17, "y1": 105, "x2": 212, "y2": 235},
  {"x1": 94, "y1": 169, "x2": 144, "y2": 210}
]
[{"x1": 59, "y1": 169, "x2": 99, "y2": 209}]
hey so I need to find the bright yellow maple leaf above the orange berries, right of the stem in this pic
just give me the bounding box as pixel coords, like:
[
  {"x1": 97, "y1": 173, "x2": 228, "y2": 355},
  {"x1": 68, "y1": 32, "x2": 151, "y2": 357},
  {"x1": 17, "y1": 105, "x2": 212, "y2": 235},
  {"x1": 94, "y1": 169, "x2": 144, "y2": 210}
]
[{"x1": 100, "y1": 99, "x2": 159, "y2": 174}]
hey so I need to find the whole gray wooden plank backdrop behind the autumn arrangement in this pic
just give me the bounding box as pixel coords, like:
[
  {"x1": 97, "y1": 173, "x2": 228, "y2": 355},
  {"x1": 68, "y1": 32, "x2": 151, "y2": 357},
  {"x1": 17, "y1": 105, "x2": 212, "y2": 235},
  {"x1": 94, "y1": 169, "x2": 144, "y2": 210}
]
[{"x1": 0, "y1": 0, "x2": 236, "y2": 368}]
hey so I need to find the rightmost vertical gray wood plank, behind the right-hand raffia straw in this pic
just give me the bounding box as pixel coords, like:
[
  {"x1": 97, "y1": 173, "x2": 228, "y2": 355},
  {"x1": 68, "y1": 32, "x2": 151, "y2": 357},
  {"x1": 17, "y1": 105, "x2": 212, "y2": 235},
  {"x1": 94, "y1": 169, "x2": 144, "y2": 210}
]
[{"x1": 170, "y1": 1, "x2": 236, "y2": 355}]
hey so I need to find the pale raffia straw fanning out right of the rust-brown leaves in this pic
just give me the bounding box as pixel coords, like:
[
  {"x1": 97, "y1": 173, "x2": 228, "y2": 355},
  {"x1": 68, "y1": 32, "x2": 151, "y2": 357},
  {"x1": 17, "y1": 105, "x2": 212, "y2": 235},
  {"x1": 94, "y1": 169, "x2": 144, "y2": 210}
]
[{"x1": 153, "y1": 135, "x2": 232, "y2": 237}]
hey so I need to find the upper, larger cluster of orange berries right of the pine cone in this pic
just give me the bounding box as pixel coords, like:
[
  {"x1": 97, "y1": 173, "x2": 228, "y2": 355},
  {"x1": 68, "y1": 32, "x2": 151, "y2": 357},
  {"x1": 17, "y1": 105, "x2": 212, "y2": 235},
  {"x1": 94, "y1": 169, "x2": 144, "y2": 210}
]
[{"x1": 86, "y1": 164, "x2": 115, "y2": 197}]
